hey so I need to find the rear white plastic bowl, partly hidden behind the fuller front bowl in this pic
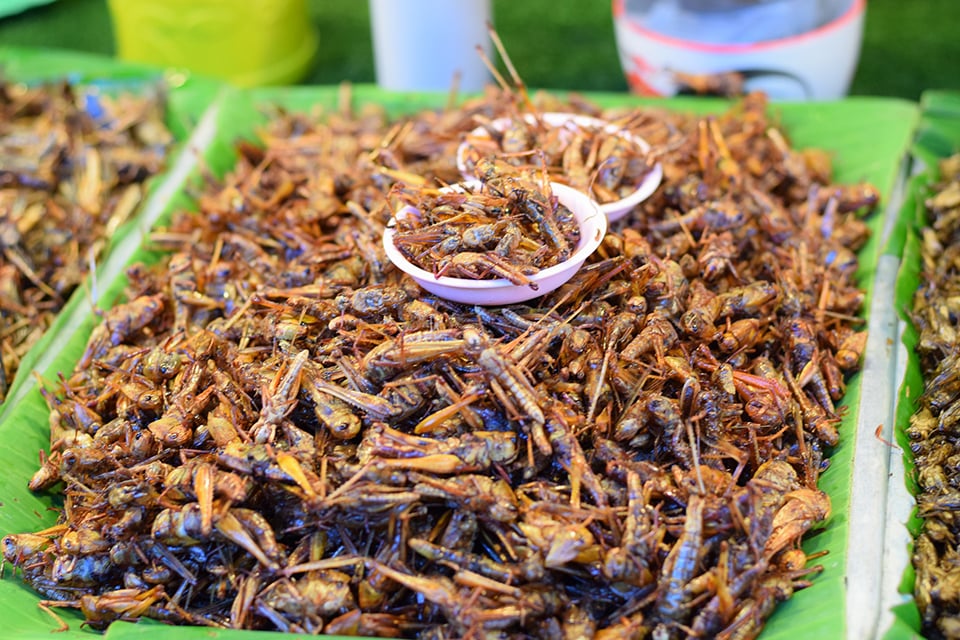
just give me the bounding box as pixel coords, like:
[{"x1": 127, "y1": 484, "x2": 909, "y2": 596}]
[{"x1": 457, "y1": 112, "x2": 663, "y2": 222}]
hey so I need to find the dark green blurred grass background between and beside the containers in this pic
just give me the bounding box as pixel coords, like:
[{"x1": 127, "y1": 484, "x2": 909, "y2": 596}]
[{"x1": 0, "y1": 0, "x2": 960, "y2": 100}]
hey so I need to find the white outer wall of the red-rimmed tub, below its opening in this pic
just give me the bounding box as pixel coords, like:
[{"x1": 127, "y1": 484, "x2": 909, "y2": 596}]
[{"x1": 612, "y1": 0, "x2": 866, "y2": 100}]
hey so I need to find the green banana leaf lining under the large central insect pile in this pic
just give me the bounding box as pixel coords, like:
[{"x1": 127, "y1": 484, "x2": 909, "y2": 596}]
[{"x1": 0, "y1": 50, "x2": 917, "y2": 640}]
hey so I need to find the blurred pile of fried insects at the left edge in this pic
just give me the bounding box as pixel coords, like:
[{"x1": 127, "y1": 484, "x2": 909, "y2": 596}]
[{"x1": 0, "y1": 77, "x2": 172, "y2": 402}]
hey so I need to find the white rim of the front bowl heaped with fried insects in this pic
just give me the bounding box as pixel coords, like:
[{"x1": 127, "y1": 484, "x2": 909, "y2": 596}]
[{"x1": 383, "y1": 180, "x2": 607, "y2": 297}]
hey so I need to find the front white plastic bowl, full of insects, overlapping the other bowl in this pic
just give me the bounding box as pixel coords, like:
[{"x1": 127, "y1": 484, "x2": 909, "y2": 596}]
[{"x1": 383, "y1": 181, "x2": 607, "y2": 306}]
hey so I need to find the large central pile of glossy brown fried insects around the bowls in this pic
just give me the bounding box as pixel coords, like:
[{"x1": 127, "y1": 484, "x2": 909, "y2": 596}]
[{"x1": 3, "y1": 32, "x2": 878, "y2": 638}]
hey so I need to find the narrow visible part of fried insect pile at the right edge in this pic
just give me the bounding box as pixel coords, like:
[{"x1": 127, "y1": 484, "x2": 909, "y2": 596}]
[{"x1": 907, "y1": 155, "x2": 960, "y2": 638}]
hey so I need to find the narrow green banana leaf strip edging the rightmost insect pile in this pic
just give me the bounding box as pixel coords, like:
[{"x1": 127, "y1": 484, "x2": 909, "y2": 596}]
[{"x1": 883, "y1": 91, "x2": 960, "y2": 640}]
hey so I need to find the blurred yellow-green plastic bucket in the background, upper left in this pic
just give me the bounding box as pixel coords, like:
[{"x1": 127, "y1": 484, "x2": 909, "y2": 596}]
[{"x1": 108, "y1": 0, "x2": 317, "y2": 87}]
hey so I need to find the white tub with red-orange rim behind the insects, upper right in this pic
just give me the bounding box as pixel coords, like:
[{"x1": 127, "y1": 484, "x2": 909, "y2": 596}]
[{"x1": 613, "y1": 0, "x2": 866, "y2": 100}]
